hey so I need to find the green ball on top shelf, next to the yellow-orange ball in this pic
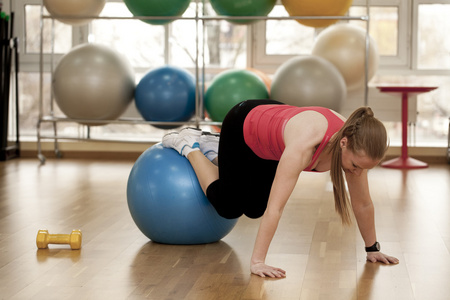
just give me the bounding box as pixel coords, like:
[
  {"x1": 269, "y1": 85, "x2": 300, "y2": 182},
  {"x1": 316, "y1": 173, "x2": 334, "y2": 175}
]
[{"x1": 210, "y1": 0, "x2": 277, "y2": 24}]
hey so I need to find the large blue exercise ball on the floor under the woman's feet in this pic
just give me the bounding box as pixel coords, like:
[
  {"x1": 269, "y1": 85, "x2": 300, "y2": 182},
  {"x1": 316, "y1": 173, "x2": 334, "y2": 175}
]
[{"x1": 127, "y1": 144, "x2": 237, "y2": 245}]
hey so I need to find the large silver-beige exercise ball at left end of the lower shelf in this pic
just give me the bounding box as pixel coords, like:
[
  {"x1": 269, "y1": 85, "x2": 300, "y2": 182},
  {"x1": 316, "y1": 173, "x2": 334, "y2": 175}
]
[{"x1": 52, "y1": 44, "x2": 135, "y2": 125}]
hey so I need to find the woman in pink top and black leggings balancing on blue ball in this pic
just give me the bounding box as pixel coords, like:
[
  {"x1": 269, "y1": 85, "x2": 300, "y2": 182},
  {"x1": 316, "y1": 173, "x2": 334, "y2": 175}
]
[{"x1": 163, "y1": 100, "x2": 398, "y2": 278}]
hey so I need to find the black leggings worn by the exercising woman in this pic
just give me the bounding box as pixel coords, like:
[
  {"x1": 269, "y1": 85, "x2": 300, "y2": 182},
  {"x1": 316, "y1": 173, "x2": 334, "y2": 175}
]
[{"x1": 206, "y1": 100, "x2": 283, "y2": 219}]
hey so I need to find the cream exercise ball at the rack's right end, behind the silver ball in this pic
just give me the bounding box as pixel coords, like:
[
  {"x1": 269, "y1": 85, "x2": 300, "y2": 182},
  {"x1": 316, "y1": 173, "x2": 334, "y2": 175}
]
[{"x1": 312, "y1": 24, "x2": 379, "y2": 91}]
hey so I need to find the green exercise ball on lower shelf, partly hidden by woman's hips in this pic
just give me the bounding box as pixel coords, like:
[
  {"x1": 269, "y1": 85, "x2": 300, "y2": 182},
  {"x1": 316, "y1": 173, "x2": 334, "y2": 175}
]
[{"x1": 204, "y1": 70, "x2": 269, "y2": 122}]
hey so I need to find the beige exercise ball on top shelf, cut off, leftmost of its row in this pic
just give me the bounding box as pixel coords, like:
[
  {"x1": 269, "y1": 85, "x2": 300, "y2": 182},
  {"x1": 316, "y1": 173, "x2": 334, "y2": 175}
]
[{"x1": 44, "y1": 0, "x2": 106, "y2": 26}]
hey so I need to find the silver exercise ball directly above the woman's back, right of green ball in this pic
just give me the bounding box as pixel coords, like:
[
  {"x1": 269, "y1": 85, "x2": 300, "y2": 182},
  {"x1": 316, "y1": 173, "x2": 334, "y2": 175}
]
[{"x1": 270, "y1": 56, "x2": 347, "y2": 111}]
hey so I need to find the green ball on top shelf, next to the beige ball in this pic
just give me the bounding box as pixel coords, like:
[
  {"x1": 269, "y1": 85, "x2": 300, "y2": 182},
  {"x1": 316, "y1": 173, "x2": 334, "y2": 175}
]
[{"x1": 124, "y1": 0, "x2": 191, "y2": 25}]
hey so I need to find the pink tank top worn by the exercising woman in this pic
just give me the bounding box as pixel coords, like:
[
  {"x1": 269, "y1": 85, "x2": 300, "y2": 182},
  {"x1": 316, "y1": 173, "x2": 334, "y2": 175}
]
[{"x1": 243, "y1": 105, "x2": 344, "y2": 171}]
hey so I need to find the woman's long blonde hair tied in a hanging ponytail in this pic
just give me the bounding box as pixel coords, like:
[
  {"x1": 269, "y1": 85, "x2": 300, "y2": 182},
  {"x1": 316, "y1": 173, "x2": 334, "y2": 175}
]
[{"x1": 329, "y1": 107, "x2": 388, "y2": 224}]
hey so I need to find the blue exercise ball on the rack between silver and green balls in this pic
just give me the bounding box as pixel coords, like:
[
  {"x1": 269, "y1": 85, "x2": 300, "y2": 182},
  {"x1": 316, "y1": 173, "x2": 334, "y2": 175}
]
[{"x1": 134, "y1": 66, "x2": 195, "y2": 128}]
